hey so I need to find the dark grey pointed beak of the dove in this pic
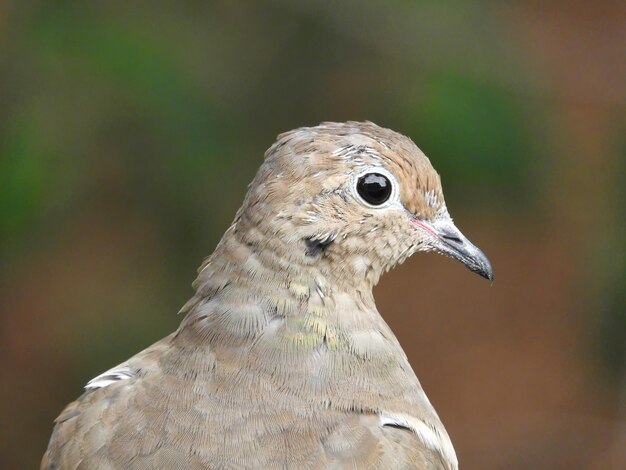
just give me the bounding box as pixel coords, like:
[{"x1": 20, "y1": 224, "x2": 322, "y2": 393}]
[{"x1": 413, "y1": 217, "x2": 493, "y2": 281}]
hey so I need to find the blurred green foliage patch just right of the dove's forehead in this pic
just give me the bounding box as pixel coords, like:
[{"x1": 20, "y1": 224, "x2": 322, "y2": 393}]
[{"x1": 402, "y1": 71, "x2": 533, "y2": 208}]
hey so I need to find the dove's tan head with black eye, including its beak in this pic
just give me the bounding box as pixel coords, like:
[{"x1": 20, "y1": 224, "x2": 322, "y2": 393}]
[{"x1": 234, "y1": 122, "x2": 493, "y2": 283}]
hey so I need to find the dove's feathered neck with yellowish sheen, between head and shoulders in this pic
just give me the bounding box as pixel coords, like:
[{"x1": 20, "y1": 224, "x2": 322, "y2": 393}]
[{"x1": 178, "y1": 229, "x2": 382, "y2": 342}]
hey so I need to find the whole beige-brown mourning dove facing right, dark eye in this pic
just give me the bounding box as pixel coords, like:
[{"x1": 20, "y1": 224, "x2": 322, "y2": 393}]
[{"x1": 41, "y1": 121, "x2": 493, "y2": 470}]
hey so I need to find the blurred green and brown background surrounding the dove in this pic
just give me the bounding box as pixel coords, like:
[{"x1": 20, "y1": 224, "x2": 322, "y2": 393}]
[{"x1": 0, "y1": 0, "x2": 626, "y2": 470}]
